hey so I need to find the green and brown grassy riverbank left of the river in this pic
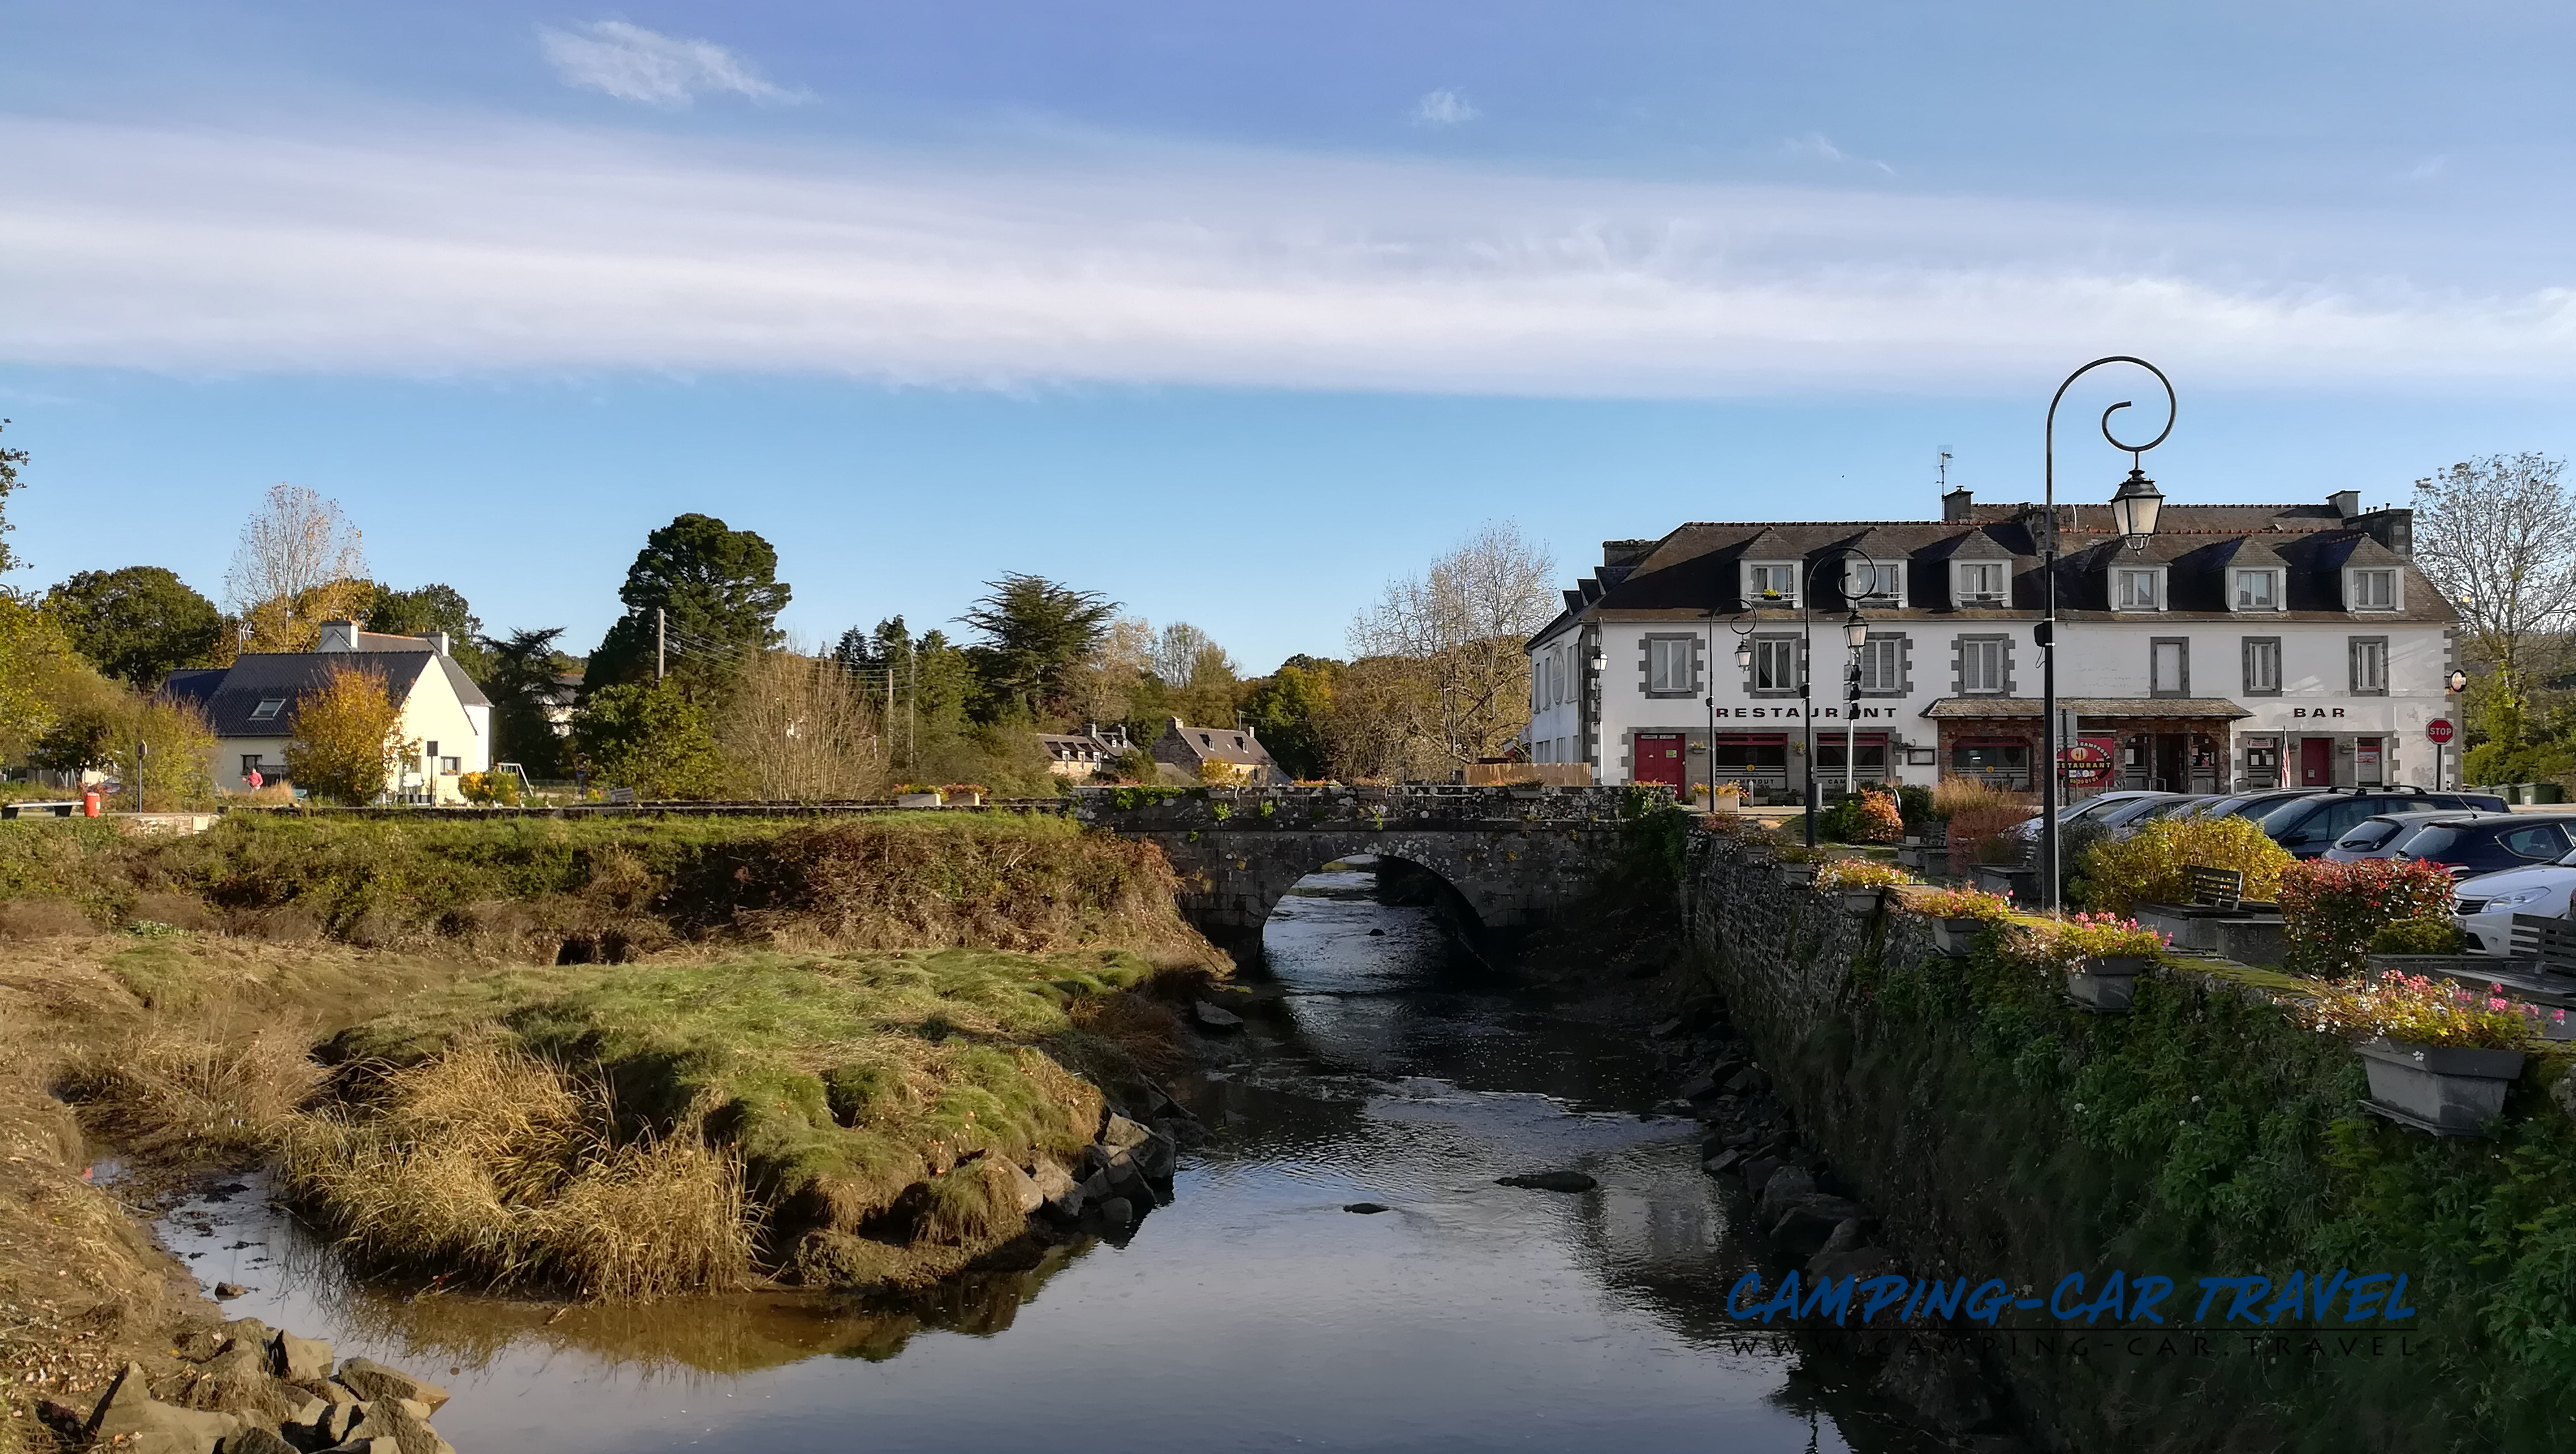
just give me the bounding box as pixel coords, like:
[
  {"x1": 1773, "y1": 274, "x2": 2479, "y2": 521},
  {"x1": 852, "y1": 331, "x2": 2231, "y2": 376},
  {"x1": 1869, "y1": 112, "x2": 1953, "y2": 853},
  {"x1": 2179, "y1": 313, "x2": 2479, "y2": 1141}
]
[{"x1": 0, "y1": 813, "x2": 1224, "y2": 1449}]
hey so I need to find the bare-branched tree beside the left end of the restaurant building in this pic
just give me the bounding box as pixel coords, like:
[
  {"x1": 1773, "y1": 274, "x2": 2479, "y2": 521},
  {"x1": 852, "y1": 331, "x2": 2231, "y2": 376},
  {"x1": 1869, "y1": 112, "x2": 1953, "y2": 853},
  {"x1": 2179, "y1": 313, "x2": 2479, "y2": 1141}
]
[{"x1": 1350, "y1": 520, "x2": 1556, "y2": 769}]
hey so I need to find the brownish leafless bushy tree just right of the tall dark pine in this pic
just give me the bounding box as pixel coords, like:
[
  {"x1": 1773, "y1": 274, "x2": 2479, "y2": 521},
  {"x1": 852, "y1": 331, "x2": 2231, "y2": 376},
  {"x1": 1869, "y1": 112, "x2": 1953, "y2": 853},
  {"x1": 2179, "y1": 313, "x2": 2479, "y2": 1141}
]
[{"x1": 716, "y1": 651, "x2": 889, "y2": 803}]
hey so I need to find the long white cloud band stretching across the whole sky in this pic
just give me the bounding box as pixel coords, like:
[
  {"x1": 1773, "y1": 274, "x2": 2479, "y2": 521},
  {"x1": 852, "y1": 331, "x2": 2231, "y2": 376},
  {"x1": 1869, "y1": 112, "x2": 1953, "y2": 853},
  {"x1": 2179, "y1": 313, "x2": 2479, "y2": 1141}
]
[{"x1": 0, "y1": 118, "x2": 2576, "y2": 397}]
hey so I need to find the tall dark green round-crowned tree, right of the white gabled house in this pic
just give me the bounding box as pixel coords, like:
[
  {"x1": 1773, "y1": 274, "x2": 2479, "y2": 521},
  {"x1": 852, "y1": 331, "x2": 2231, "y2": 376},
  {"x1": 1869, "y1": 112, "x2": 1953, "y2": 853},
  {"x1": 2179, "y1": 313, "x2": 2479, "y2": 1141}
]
[{"x1": 588, "y1": 515, "x2": 791, "y2": 697}]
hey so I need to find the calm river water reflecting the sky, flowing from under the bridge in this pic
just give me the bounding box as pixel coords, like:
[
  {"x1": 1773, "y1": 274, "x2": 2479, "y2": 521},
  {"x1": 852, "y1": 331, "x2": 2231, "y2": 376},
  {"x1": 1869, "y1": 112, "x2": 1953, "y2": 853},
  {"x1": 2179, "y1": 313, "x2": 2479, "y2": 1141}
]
[{"x1": 162, "y1": 865, "x2": 1927, "y2": 1454}]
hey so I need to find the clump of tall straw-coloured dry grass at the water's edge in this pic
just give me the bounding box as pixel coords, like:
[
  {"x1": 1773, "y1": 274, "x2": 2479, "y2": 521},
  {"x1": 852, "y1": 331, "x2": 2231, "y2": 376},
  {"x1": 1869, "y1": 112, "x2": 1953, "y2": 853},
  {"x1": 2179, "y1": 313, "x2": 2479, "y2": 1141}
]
[{"x1": 283, "y1": 1045, "x2": 758, "y2": 1300}]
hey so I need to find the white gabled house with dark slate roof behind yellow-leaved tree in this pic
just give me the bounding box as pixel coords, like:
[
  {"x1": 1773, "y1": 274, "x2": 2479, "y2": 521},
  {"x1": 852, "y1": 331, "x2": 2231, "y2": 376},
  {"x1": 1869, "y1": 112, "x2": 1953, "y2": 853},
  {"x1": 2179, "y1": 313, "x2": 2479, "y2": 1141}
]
[{"x1": 162, "y1": 620, "x2": 492, "y2": 803}]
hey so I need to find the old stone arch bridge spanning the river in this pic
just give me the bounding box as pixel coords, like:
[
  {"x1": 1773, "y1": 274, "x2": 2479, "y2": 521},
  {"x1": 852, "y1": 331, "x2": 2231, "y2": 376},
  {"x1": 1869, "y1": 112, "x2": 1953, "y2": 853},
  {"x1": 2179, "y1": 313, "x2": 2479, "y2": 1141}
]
[{"x1": 1074, "y1": 785, "x2": 1628, "y2": 963}]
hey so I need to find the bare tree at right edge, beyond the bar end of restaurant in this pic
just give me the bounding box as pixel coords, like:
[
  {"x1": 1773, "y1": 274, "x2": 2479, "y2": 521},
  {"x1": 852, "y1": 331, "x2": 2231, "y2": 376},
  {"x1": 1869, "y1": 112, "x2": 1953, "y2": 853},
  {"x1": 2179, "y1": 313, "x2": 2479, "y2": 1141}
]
[{"x1": 2414, "y1": 453, "x2": 2576, "y2": 746}]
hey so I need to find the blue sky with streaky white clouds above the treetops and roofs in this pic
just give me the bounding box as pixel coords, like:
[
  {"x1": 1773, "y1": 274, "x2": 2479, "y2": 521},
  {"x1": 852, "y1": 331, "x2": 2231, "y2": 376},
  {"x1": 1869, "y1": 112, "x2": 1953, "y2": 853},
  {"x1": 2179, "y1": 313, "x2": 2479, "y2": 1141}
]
[{"x1": 0, "y1": 0, "x2": 2576, "y2": 669}]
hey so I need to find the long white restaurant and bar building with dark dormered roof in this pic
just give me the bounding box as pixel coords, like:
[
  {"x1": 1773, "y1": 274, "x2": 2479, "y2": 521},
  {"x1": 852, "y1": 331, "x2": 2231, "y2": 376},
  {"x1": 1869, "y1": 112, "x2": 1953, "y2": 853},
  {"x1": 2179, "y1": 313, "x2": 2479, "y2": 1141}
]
[{"x1": 1525, "y1": 489, "x2": 2457, "y2": 798}]
